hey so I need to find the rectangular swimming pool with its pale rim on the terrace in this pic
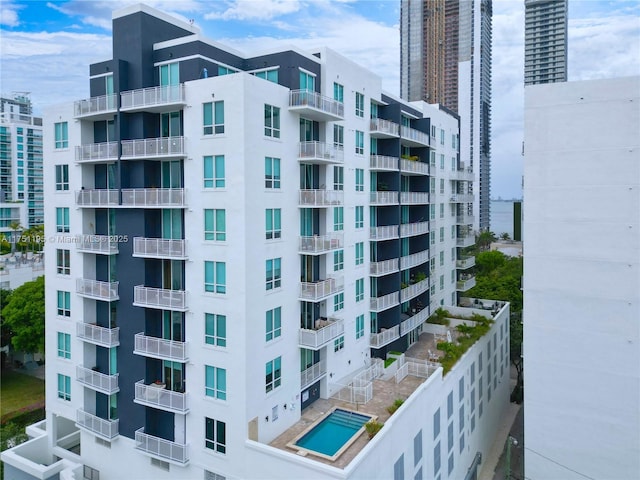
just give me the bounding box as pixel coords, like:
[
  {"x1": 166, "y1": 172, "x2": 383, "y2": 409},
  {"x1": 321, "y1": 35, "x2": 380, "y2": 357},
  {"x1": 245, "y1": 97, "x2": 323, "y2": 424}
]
[{"x1": 289, "y1": 408, "x2": 374, "y2": 460}]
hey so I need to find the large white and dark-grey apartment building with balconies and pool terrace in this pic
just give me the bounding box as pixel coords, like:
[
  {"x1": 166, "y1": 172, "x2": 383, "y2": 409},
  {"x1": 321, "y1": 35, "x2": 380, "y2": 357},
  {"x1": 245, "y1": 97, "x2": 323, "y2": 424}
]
[{"x1": 2, "y1": 5, "x2": 509, "y2": 480}]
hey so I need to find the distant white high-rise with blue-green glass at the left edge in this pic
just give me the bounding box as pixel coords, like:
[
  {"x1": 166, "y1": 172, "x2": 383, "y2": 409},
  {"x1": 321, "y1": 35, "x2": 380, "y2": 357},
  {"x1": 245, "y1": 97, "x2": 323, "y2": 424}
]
[{"x1": 0, "y1": 94, "x2": 44, "y2": 233}]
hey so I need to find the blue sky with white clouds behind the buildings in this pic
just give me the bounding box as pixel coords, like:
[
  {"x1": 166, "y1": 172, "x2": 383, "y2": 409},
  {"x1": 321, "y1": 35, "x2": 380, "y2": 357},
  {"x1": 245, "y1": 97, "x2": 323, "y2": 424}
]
[{"x1": 0, "y1": 0, "x2": 640, "y2": 198}]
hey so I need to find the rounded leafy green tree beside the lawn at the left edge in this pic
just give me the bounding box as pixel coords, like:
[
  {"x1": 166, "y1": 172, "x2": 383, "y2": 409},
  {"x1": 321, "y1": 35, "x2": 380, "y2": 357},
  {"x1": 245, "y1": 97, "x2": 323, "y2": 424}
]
[{"x1": 2, "y1": 276, "x2": 44, "y2": 353}]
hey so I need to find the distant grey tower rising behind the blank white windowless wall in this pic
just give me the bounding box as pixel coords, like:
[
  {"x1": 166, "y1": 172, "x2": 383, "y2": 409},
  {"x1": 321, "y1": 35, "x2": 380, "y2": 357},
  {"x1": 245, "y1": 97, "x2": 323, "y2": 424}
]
[{"x1": 524, "y1": 0, "x2": 569, "y2": 85}]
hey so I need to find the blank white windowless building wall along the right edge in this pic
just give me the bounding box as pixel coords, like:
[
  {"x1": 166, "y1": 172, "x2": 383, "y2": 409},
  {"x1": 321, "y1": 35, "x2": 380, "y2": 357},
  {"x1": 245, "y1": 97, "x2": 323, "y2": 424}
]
[{"x1": 523, "y1": 77, "x2": 640, "y2": 480}]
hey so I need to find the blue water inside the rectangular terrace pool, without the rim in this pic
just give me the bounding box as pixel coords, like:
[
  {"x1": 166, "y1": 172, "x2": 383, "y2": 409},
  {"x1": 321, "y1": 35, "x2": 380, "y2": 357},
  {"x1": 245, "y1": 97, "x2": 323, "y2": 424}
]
[{"x1": 296, "y1": 409, "x2": 371, "y2": 457}]
